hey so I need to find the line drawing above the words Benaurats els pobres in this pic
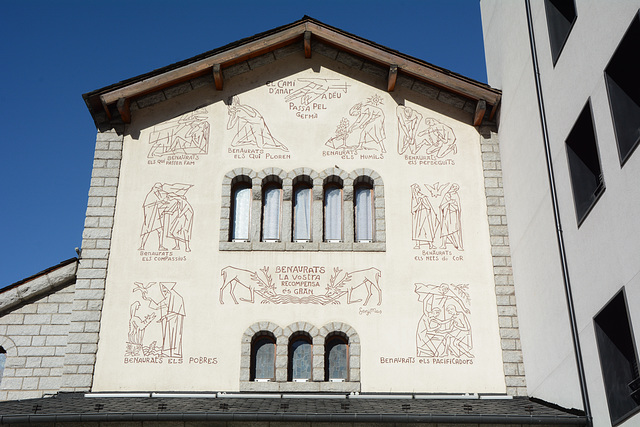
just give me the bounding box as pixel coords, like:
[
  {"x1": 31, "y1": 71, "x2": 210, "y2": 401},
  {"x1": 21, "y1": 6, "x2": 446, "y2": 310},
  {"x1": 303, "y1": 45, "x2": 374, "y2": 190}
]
[{"x1": 125, "y1": 282, "x2": 186, "y2": 358}]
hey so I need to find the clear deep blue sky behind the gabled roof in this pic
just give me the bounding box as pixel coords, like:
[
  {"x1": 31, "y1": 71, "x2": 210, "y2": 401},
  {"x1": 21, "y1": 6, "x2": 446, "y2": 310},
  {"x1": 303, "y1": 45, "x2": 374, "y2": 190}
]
[{"x1": 0, "y1": 0, "x2": 486, "y2": 287}]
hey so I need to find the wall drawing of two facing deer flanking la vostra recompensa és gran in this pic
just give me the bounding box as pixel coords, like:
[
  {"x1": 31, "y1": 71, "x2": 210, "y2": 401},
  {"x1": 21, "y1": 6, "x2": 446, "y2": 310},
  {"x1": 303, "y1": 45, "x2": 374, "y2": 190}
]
[{"x1": 220, "y1": 266, "x2": 382, "y2": 306}]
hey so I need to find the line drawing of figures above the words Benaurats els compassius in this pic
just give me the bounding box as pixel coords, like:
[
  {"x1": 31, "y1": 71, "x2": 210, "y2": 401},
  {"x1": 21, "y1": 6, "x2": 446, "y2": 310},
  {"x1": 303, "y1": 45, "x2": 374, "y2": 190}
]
[{"x1": 138, "y1": 182, "x2": 193, "y2": 252}]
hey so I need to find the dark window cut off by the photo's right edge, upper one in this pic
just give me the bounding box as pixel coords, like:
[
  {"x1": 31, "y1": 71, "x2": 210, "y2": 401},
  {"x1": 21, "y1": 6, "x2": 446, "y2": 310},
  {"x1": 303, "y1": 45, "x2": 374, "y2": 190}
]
[{"x1": 604, "y1": 14, "x2": 640, "y2": 165}]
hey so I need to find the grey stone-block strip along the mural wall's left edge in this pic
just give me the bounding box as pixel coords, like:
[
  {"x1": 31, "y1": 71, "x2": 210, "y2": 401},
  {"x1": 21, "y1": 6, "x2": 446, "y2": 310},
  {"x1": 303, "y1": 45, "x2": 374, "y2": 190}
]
[{"x1": 60, "y1": 129, "x2": 124, "y2": 391}]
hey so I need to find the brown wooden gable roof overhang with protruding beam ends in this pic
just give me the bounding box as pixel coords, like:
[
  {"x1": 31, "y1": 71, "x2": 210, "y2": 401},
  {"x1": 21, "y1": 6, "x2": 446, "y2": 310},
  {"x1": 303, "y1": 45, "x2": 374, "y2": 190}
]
[{"x1": 83, "y1": 16, "x2": 501, "y2": 128}]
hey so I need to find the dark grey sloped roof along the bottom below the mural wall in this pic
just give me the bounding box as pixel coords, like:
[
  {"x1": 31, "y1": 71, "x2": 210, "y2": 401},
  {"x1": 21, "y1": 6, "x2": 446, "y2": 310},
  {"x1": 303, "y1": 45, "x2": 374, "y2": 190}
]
[{"x1": 0, "y1": 393, "x2": 586, "y2": 425}]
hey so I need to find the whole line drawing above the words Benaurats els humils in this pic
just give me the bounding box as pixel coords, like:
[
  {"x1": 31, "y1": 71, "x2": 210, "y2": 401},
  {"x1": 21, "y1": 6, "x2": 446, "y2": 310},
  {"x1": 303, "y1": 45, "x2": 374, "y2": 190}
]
[{"x1": 325, "y1": 95, "x2": 387, "y2": 153}]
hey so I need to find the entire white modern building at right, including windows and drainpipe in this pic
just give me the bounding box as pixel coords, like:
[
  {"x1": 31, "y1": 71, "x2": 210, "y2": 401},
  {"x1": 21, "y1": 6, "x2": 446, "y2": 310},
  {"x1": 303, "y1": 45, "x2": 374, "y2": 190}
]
[{"x1": 481, "y1": 0, "x2": 640, "y2": 426}]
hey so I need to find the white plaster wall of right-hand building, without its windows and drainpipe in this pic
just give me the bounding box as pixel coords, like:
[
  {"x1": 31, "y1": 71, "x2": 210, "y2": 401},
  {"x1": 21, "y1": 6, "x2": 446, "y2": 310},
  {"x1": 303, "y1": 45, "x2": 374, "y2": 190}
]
[{"x1": 481, "y1": 0, "x2": 640, "y2": 426}]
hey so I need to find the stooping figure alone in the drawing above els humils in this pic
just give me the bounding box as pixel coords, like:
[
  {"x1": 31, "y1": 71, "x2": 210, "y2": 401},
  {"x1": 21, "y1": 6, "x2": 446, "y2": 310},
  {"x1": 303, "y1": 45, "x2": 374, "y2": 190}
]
[{"x1": 349, "y1": 96, "x2": 387, "y2": 153}]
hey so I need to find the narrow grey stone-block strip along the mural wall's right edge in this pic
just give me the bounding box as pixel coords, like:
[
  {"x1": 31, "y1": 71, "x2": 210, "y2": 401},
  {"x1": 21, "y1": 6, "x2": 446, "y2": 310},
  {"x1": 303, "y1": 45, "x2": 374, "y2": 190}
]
[{"x1": 478, "y1": 126, "x2": 527, "y2": 396}]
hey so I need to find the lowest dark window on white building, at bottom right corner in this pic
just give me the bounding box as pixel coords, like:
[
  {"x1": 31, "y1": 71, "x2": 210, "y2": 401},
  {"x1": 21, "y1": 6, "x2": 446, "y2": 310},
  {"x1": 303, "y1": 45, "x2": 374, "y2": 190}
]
[{"x1": 594, "y1": 291, "x2": 640, "y2": 425}]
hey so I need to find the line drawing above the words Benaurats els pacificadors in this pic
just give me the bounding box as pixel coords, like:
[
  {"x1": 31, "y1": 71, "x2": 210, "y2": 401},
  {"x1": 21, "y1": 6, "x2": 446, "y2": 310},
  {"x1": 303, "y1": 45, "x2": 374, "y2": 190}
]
[{"x1": 414, "y1": 283, "x2": 474, "y2": 358}]
